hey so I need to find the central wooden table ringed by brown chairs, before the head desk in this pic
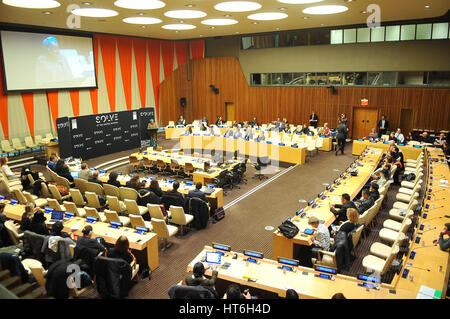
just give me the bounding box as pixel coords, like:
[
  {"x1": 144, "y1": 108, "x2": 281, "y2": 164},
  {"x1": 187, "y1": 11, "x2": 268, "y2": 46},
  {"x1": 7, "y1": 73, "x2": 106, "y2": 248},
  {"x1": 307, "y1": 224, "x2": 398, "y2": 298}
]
[{"x1": 130, "y1": 150, "x2": 240, "y2": 189}]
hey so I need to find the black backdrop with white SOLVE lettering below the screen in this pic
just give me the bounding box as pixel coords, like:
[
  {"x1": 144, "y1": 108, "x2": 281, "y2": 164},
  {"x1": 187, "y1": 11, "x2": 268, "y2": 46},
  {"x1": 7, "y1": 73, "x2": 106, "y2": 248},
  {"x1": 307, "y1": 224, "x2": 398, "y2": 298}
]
[{"x1": 56, "y1": 108, "x2": 155, "y2": 159}]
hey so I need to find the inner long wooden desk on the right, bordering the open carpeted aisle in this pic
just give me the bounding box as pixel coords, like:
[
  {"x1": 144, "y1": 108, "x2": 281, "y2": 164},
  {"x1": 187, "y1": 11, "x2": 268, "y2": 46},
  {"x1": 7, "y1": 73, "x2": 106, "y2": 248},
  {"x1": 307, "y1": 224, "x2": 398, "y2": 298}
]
[{"x1": 272, "y1": 148, "x2": 382, "y2": 259}]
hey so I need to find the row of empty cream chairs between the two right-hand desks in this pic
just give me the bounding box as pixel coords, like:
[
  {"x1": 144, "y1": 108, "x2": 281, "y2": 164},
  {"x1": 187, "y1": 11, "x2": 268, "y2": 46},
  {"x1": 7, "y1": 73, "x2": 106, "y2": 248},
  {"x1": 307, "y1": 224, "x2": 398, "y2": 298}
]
[{"x1": 362, "y1": 154, "x2": 423, "y2": 275}]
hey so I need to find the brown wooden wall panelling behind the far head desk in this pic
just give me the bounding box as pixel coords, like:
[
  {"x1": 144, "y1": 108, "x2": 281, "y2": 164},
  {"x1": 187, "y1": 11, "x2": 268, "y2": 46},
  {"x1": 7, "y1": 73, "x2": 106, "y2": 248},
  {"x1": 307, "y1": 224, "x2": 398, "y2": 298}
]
[{"x1": 160, "y1": 57, "x2": 450, "y2": 137}]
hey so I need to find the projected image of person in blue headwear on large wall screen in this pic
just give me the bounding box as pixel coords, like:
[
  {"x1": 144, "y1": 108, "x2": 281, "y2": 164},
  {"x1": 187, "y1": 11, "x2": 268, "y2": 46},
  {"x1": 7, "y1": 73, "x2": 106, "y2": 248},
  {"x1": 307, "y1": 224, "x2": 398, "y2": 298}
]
[{"x1": 1, "y1": 31, "x2": 96, "y2": 91}]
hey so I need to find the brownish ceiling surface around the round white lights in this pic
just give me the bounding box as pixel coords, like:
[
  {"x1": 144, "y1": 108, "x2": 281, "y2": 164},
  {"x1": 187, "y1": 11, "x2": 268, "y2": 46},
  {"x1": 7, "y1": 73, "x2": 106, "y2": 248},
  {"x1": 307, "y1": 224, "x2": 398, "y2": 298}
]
[{"x1": 0, "y1": 0, "x2": 450, "y2": 40}]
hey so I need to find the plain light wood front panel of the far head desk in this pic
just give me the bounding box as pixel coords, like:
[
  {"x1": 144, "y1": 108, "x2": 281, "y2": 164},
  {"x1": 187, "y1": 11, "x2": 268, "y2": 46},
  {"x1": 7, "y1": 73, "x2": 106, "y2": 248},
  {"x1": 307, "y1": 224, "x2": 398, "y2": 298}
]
[{"x1": 180, "y1": 135, "x2": 306, "y2": 164}]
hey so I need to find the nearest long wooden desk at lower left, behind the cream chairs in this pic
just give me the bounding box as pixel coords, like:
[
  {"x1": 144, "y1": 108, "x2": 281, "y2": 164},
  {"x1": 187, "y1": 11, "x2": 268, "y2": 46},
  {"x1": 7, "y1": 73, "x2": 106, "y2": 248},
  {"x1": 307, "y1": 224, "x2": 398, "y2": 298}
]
[{"x1": 0, "y1": 199, "x2": 159, "y2": 270}]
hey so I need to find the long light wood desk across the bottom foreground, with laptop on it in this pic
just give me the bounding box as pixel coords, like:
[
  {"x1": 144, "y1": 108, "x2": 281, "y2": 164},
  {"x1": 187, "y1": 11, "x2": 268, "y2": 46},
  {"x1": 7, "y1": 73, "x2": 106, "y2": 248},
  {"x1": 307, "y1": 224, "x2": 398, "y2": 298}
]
[{"x1": 186, "y1": 246, "x2": 415, "y2": 299}]
